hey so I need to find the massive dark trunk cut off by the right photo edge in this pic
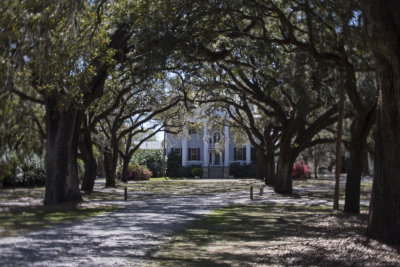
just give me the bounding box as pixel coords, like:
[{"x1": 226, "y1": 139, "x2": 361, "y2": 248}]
[{"x1": 363, "y1": 0, "x2": 400, "y2": 243}]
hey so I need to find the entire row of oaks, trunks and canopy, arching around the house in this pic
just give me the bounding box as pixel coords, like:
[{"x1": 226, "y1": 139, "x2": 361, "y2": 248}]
[{"x1": 0, "y1": 0, "x2": 400, "y2": 245}]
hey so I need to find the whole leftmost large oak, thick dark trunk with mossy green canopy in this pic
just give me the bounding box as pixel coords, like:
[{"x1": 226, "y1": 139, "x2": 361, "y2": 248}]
[{"x1": 2, "y1": 1, "x2": 189, "y2": 204}]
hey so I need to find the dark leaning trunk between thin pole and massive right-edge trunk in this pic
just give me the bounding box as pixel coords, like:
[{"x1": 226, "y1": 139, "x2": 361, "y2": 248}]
[{"x1": 344, "y1": 109, "x2": 376, "y2": 213}]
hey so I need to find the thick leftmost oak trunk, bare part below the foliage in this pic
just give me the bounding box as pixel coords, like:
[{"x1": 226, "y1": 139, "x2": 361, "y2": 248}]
[{"x1": 44, "y1": 99, "x2": 82, "y2": 205}]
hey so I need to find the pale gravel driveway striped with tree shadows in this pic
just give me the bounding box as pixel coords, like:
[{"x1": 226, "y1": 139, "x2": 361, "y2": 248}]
[{"x1": 0, "y1": 192, "x2": 256, "y2": 266}]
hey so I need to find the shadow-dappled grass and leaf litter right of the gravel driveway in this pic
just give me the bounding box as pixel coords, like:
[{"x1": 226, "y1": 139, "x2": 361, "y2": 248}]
[{"x1": 150, "y1": 204, "x2": 400, "y2": 266}]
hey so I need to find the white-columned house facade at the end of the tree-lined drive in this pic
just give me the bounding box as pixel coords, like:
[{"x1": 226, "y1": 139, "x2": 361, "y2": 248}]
[{"x1": 166, "y1": 121, "x2": 254, "y2": 178}]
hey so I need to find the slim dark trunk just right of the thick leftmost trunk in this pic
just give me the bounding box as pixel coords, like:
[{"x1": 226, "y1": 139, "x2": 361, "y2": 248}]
[{"x1": 79, "y1": 125, "x2": 97, "y2": 192}]
